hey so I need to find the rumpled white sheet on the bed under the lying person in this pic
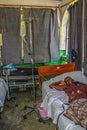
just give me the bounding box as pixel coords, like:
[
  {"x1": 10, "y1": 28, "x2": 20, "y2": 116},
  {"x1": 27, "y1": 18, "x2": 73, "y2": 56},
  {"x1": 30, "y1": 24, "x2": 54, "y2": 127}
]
[{"x1": 42, "y1": 71, "x2": 87, "y2": 130}]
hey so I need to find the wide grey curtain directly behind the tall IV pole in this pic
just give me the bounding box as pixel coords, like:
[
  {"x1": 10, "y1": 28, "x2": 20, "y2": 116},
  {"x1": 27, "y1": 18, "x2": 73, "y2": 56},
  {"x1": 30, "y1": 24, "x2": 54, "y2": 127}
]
[{"x1": 24, "y1": 8, "x2": 51, "y2": 63}]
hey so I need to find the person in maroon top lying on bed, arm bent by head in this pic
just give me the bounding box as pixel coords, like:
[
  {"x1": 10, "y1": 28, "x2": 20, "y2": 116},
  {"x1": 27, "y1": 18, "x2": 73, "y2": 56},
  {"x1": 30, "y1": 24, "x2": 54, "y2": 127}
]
[{"x1": 49, "y1": 77, "x2": 87, "y2": 102}]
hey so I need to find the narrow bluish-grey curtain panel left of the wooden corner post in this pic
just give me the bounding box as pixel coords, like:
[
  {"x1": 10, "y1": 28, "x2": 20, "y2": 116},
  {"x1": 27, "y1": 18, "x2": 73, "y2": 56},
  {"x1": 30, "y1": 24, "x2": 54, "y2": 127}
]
[{"x1": 50, "y1": 9, "x2": 59, "y2": 61}]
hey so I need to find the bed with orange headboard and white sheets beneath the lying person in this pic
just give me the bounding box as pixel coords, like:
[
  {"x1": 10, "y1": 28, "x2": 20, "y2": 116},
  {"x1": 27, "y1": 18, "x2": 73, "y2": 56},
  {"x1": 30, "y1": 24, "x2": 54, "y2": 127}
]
[{"x1": 38, "y1": 63, "x2": 87, "y2": 130}]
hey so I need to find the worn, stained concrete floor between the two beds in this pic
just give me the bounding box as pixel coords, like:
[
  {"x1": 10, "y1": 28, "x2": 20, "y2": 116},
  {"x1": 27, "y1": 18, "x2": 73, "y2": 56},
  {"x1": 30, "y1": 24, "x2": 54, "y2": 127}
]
[{"x1": 0, "y1": 90, "x2": 55, "y2": 130}]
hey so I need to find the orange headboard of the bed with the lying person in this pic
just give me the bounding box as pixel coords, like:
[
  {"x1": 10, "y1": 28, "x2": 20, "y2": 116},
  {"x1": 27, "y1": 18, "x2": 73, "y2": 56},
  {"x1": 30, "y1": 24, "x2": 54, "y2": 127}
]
[{"x1": 38, "y1": 63, "x2": 75, "y2": 88}]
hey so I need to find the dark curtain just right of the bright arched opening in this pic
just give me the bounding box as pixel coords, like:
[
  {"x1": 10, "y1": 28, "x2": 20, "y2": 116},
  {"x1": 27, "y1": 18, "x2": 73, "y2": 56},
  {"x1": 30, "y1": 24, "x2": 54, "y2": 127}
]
[{"x1": 68, "y1": 3, "x2": 78, "y2": 52}]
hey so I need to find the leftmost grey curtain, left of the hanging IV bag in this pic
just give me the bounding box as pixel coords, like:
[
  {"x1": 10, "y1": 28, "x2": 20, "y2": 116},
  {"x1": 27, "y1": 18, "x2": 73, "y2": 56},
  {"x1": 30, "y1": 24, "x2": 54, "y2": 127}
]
[{"x1": 0, "y1": 7, "x2": 21, "y2": 65}]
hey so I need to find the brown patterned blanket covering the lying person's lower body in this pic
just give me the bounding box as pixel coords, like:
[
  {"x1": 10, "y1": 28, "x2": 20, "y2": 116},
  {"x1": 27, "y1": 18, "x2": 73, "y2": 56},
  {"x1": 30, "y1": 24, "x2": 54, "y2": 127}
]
[{"x1": 65, "y1": 98, "x2": 87, "y2": 129}]
